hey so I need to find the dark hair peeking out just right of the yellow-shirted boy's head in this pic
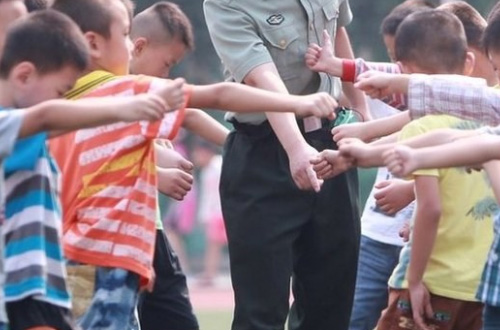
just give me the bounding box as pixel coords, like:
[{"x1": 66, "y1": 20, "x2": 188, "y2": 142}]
[{"x1": 437, "y1": 1, "x2": 487, "y2": 50}]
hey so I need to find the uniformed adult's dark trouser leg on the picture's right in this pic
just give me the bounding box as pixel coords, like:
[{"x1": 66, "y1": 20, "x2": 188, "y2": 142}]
[{"x1": 289, "y1": 141, "x2": 360, "y2": 330}]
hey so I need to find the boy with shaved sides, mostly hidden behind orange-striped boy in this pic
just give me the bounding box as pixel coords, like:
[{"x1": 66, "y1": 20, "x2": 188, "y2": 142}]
[{"x1": 130, "y1": 1, "x2": 200, "y2": 330}]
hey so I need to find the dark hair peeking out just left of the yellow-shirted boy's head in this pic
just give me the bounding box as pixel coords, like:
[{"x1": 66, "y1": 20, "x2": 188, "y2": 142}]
[{"x1": 380, "y1": 0, "x2": 435, "y2": 36}]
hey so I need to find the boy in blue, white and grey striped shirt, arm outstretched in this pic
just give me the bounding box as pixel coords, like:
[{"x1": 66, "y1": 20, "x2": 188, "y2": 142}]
[{"x1": 0, "y1": 7, "x2": 193, "y2": 329}]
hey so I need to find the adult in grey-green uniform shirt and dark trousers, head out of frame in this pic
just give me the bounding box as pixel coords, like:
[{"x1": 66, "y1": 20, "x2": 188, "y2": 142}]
[{"x1": 204, "y1": 0, "x2": 367, "y2": 330}]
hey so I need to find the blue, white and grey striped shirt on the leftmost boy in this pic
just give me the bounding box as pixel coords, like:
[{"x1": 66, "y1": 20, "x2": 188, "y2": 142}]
[{"x1": 2, "y1": 133, "x2": 71, "y2": 308}]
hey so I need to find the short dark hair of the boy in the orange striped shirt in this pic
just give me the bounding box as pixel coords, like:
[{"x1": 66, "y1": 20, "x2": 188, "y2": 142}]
[{"x1": 52, "y1": 0, "x2": 134, "y2": 38}]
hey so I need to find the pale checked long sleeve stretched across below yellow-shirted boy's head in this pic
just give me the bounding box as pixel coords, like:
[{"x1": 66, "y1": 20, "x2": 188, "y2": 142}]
[{"x1": 408, "y1": 75, "x2": 500, "y2": 126}]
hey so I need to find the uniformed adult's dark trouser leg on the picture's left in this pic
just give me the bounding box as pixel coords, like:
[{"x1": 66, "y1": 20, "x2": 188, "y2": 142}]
[{"x1": 220, "y1": 124, "x2": 315, "y2": 330}]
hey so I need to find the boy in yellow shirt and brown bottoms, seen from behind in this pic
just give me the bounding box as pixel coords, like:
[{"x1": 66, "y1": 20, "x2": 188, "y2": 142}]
[{"x1": 341, "y1": 11, "x2": 495, "y2": 329}]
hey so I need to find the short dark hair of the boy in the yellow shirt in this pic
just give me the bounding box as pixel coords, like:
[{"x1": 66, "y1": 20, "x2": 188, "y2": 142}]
[{"x1": 395, "y1": 9, "x2": 467, "y2": 73}]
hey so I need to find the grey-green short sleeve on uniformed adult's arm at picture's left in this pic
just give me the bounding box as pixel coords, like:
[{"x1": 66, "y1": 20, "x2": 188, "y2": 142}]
[{"x1": 204, "y1": 0, "x2": 273, "y2": 82}]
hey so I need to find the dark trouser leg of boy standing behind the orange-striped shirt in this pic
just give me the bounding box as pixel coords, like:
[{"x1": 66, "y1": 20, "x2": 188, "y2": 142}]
[{"x1": 138, "y1": 230, "x2": 199, "y2": 330}]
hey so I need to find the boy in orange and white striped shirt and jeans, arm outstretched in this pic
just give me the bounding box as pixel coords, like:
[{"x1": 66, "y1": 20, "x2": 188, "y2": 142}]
[{"x1": 51, "y1": 0, "x2": 336, "y2": 330}]
